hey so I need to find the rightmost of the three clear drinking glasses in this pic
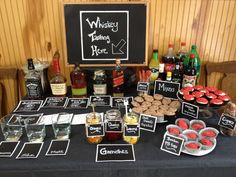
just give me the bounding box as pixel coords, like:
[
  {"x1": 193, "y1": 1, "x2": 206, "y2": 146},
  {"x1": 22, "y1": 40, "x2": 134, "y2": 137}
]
[{"x1": 52, "y1": 113, "x2": 73, "y2": 139}]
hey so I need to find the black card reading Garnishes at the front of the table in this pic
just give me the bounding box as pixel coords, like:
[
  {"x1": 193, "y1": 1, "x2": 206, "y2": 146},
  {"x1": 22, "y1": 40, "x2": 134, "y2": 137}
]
[{"x1": 96, "y1": 144, "x2": 135, "y2": 162}]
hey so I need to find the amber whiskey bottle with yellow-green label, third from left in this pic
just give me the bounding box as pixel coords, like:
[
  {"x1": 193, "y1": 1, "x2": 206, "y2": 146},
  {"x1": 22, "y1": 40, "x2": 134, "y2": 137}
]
[{"x1": 70, "y1": 63, "x2": 87, "y2": 97}]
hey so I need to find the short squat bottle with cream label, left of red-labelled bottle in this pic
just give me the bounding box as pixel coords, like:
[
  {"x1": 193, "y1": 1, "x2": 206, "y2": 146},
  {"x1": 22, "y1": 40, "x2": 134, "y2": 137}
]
[{"x1": 93, "y1": 70, "x2": 107, "y2": 95}]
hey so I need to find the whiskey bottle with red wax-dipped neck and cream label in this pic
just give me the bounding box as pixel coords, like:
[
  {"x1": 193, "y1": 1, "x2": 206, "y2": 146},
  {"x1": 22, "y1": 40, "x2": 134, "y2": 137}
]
[{"x1": 50, "y1": 51, "x2": 67, "y2": 96}]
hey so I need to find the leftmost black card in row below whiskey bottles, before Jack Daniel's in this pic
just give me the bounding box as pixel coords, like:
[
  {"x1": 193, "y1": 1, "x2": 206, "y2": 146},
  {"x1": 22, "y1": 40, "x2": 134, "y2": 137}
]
[{"x1": 13, "y1": 100, "x2": 43, "y2": 112}]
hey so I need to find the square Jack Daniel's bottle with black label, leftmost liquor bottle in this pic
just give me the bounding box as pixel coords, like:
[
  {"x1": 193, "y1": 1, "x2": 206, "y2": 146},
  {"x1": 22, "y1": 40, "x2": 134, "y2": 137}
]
[{"x1": 25, "y1": 58, "x2": 43, "y2": 99}]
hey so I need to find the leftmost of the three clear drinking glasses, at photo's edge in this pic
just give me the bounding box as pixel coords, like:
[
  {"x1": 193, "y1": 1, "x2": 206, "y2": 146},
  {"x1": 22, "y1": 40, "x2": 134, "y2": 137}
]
[{"x1": 0, "y1": 117, "x2": 23, "y2": 141}]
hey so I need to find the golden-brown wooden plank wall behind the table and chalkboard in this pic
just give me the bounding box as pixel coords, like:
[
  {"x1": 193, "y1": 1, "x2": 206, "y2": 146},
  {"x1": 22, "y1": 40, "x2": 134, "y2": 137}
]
[{"x1": 0, "y1": 0, "x2": 236, "y2": 112}]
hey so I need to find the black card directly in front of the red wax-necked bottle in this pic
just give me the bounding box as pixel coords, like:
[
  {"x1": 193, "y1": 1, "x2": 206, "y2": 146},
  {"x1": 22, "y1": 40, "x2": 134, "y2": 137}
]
[{"x1": 43, "y1": 97, "x2": 68, "y2": 108}]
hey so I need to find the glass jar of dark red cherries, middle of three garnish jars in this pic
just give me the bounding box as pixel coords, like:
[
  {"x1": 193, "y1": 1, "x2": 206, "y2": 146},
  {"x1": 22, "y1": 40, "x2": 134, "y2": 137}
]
[{"x1": 105, "y1": 109, "x2": 122, "y2": 141}]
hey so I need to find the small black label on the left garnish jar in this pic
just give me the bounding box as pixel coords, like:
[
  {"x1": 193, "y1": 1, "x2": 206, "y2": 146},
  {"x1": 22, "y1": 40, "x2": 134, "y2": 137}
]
[{"x1": 86, "y1": 123, "x2": 104, "y2": 137}]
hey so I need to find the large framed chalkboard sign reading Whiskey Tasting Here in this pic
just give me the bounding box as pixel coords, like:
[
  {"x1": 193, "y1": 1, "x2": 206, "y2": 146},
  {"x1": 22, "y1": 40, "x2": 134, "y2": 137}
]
[{"x1": 64, "y1": 3, "x2": 148, "y2": 66}]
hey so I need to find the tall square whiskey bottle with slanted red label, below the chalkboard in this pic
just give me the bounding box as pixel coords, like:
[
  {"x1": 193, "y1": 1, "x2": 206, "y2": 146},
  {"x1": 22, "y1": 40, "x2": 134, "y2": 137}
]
[{"x1": 112, "y1": 59, "x2": 124, "y2": 97}]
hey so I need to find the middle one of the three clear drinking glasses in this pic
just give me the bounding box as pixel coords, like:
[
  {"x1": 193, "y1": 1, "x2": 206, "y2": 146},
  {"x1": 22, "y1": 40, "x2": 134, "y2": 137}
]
[{"x1": 24, "y1": 119, "x2": 46, "y2": 142}]
